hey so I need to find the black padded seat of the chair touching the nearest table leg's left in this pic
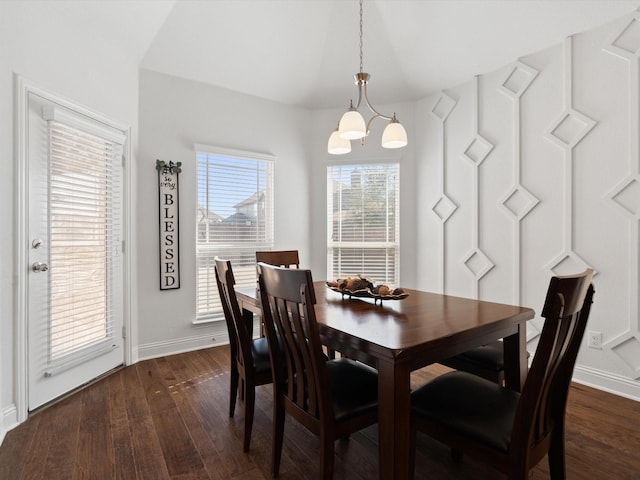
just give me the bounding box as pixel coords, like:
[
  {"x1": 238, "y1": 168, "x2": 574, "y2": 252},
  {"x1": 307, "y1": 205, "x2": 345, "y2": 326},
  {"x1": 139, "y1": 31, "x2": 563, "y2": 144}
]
[{"x1": 326, "y1": 358, "x2": 378, "y2": 422}]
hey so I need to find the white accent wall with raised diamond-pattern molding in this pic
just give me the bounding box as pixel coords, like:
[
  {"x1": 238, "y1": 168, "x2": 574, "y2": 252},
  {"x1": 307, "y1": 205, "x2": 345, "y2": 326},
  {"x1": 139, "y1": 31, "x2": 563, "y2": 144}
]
[{"x1": 416, "y1": 13, "x2": 640, "y2": 399}]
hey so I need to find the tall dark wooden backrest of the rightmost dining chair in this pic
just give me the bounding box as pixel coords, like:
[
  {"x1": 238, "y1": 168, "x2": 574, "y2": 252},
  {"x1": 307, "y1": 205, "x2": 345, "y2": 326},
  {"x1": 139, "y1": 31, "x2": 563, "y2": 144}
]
[{"x1": 511, "y1": 270, "x2": 594, "y2": 458}]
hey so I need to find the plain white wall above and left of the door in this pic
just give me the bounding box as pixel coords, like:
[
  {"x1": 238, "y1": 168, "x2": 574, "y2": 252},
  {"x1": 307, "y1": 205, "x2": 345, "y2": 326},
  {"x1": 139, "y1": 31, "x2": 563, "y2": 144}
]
[{"x1": 0, "y1": 2, "x2": 138, "y2": 438}]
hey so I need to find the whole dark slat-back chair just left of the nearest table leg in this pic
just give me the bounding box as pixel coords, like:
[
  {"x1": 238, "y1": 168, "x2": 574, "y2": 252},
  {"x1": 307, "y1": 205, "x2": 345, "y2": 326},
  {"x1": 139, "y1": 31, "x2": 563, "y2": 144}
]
[{"x1": 258, "y1": 263, "x2": 378, "y2": 480}]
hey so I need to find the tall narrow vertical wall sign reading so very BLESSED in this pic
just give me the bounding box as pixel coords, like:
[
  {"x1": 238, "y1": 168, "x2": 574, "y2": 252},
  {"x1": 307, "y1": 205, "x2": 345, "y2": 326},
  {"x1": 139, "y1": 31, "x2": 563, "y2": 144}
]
[{"x1": 156, "y1": 160, "x2": 182, "y2": 290}]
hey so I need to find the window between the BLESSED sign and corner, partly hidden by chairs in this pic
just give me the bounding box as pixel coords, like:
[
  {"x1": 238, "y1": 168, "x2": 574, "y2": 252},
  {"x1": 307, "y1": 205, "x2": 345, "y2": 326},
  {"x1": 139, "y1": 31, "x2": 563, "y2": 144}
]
[{"x1": 195, "y1": 145, "x2": 274, "y2": 322}]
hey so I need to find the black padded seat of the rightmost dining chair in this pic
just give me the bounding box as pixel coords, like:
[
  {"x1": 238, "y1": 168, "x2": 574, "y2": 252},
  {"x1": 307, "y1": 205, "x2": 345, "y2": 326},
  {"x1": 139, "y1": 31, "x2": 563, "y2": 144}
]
[{"x1": 411, "y1": 371, "x2": 520, "y2": 453}]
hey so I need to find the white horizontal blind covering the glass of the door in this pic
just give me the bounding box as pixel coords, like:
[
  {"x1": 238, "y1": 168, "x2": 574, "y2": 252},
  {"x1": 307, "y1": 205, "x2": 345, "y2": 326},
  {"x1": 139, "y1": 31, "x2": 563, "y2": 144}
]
[{"x1": 45, "y1": 115, "x2": 125, "y2": 373}]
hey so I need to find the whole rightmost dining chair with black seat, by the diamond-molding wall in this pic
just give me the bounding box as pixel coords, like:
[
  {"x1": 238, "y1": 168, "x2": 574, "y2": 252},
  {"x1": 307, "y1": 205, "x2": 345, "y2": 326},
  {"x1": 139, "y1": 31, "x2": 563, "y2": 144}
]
[{"x1": 410, "y1": 269, "x2": 594, "y2": 480}]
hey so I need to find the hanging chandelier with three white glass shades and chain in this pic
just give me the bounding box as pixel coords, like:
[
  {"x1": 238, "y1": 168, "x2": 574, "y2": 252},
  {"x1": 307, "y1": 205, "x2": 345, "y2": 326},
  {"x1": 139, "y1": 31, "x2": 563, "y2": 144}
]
[{"x1": 327, "y1": 0, "x2": 407, "y2": 155}]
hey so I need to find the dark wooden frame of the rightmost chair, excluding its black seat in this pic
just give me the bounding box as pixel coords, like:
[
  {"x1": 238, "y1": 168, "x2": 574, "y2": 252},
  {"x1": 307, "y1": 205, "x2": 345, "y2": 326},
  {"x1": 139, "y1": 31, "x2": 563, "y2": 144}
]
[{"x1": 411, "y1": 270, "x2": 594, "y2": 480}]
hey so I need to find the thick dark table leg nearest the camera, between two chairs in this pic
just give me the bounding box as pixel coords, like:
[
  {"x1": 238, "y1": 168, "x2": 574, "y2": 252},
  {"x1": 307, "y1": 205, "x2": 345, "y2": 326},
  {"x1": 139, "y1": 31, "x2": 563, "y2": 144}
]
[{"x1": 378, "y1": 359, "x2": 411, "y2": 480}]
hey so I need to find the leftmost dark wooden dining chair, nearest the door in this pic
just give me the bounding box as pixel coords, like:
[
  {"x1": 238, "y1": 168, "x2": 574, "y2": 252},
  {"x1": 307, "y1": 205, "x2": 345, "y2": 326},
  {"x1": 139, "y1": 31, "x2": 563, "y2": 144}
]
[{"x1": 215, "y1": 257, "x2": 272, "y2": 452}]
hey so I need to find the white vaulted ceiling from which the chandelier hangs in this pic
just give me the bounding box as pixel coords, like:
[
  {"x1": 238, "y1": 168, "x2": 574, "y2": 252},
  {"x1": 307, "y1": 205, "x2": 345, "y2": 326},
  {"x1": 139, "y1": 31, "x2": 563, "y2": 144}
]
[{"x1": 36, "y1": 0, "x2": 640, "y2": 108}]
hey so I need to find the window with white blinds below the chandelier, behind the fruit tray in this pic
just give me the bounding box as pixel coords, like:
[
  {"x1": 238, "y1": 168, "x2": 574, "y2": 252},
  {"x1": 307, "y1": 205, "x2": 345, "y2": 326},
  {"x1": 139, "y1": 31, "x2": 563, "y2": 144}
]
[{"x1": 327, "y1": 163, "x2": 400, "y2": 286}]
